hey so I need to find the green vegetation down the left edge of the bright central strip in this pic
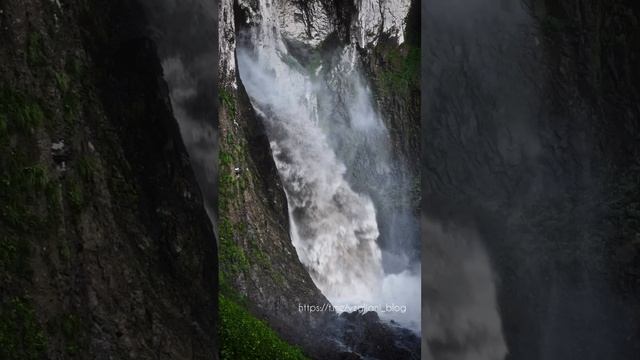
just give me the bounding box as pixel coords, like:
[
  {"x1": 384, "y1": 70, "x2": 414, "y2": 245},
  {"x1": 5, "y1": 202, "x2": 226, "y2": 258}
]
[{"x1": 218, "y1": 89, "x2": 306, "y2": 360}]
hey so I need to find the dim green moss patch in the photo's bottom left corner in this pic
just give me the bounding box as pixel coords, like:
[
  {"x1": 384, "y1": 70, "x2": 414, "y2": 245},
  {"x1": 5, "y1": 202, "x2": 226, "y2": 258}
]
[{"x1": 0, "y1": 298, "x2": 47, "y2": 360}]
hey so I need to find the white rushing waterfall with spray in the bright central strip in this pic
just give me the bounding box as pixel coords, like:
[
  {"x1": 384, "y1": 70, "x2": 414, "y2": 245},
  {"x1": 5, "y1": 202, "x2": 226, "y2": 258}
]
[{"x1": 237, "y1": 0, "x2": 420, "y2": 330}]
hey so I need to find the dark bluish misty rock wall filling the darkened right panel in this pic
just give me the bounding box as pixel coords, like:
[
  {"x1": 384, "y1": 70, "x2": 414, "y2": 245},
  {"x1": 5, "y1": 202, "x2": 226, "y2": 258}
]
[{"x1": 422, "y1": 0, "x2": 640, "y2": 359}]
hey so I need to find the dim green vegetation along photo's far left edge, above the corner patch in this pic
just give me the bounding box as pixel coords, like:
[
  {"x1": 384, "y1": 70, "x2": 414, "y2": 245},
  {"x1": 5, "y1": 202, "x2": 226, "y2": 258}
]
[{"x1": 0, "y1": 88, "x2": 59, "y2": 283}]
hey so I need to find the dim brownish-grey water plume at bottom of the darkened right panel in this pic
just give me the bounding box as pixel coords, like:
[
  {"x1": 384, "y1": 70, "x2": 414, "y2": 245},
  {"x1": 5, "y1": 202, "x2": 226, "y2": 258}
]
[{"x1": 422, "y1": 218, "x2": 507, "y2": 360}]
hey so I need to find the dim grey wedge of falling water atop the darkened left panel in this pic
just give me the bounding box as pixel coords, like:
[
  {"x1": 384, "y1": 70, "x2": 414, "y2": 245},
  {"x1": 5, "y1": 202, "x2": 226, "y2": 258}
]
[{"x1": 136, "y1": 0, "x2": 218, "y2": 228}]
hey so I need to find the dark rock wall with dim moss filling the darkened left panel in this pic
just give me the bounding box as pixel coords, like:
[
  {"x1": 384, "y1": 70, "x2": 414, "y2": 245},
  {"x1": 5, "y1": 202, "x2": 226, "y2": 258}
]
[{"x1": 0, "y1": 1, "x2": 217, "y2": 359}]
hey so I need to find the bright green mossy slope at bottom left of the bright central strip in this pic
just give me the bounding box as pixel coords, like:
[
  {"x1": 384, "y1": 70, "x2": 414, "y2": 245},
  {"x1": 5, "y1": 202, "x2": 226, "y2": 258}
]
[{"x1": 219, "y1": 295, "x2": 307, "y2": 360}]
